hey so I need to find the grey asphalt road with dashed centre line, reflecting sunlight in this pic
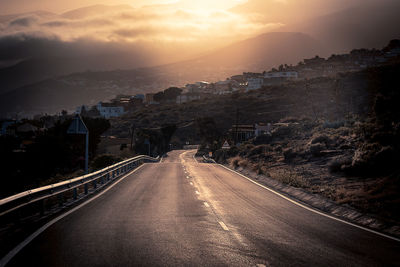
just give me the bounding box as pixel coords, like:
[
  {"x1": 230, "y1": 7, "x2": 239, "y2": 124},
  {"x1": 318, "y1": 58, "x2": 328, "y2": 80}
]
[{"x1": 3, "y1": 151, "x2": 400, "y2": 267}]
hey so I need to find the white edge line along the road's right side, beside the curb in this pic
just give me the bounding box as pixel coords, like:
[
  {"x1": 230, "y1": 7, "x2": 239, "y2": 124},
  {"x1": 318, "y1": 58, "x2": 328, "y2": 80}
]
[{"x1": 218, "y1": 164, "x2": 400, "y2": 242}]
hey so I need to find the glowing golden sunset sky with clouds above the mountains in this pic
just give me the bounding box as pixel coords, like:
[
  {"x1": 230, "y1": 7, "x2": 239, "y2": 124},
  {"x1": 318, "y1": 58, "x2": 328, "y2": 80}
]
[{"x1": 0, "y1": 0, "x2": 394, "y2": 70}]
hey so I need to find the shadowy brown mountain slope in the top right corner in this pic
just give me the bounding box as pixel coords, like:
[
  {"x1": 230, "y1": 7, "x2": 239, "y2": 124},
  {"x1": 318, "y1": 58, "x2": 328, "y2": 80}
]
[{"x1": 280, "y1": 0, "x2": 400, "y2": 53}]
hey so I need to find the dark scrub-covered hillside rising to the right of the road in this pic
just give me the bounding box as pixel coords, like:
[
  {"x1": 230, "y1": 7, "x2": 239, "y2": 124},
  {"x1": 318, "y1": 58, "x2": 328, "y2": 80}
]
[{"x1": 107, "y1": 63, "x2": 400, "y2": 226}]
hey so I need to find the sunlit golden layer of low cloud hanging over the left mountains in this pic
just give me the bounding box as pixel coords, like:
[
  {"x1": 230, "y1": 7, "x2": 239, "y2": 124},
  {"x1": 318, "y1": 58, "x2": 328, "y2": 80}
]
[{"x1": 0, "y1": 5, "x2": 282, "y2": 67}]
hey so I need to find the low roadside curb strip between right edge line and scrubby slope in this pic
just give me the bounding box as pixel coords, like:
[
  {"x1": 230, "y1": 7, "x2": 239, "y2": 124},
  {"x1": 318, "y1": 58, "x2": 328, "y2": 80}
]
[{"x1": 218, "y1": 164, "x2": 400, "y2": 241}]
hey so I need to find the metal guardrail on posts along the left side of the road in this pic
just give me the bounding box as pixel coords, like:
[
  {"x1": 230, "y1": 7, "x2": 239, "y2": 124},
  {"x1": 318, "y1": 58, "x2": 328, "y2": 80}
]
[{"x1": 0, "y1": 155, "x2": 159, "y2": 220}]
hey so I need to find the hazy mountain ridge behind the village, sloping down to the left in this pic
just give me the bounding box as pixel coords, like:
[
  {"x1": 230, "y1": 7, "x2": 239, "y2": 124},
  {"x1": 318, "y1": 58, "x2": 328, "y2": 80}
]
[{"x1": 0, "y1": 32, "x2": 324, "y2": 117}]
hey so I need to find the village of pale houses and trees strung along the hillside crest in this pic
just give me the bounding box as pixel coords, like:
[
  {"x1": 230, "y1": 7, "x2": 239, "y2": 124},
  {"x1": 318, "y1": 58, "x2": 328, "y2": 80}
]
[{"x1": 72, "y1": 40, "x2": 400, "y2": 119}]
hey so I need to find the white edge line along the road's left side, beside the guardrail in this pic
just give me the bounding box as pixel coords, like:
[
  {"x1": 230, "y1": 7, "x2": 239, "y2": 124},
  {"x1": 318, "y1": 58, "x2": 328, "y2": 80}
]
[{"x1": 0, "y1": 164, "x2": 145, "y2": 266}]
